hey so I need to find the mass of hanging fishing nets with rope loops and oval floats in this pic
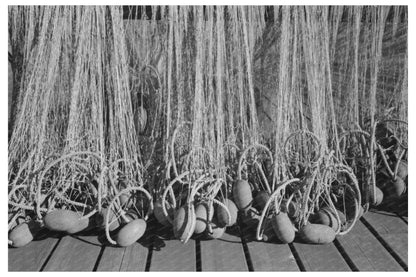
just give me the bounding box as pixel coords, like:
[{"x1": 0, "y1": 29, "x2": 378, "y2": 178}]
[{"x1": 8, "y1": 6, "x2": 408, "y2": 246}]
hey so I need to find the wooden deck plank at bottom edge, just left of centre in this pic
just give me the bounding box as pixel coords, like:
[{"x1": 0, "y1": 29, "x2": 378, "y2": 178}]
[{"x1": 150, "y1": 236, "x2": 196, "y2": 271}]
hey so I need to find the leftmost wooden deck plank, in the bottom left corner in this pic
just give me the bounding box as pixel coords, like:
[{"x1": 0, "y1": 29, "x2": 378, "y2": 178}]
[{"x1": 8, "y1": 233, "x2": 59, "y2": 271}]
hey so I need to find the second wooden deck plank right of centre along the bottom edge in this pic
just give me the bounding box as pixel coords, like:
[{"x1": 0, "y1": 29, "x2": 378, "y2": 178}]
[{"x1": 247, "y1": 241, "x2": 299, "y2": 271}]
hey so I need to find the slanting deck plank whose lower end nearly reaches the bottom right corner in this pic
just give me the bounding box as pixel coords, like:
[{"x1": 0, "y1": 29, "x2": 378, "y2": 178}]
[{"x1": 338, "y1": 218, "x2": 403, "y2": 271}]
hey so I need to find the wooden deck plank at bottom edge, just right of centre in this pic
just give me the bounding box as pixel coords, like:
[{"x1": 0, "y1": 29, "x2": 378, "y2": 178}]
[{"x1": 201, "y1": 230, "x2": 248, "y2": 271}]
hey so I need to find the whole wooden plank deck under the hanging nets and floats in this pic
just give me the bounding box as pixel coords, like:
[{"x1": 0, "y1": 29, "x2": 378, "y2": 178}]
[{"x1": 8, "y1": 211, "x2": 408, "y2": 271}]
